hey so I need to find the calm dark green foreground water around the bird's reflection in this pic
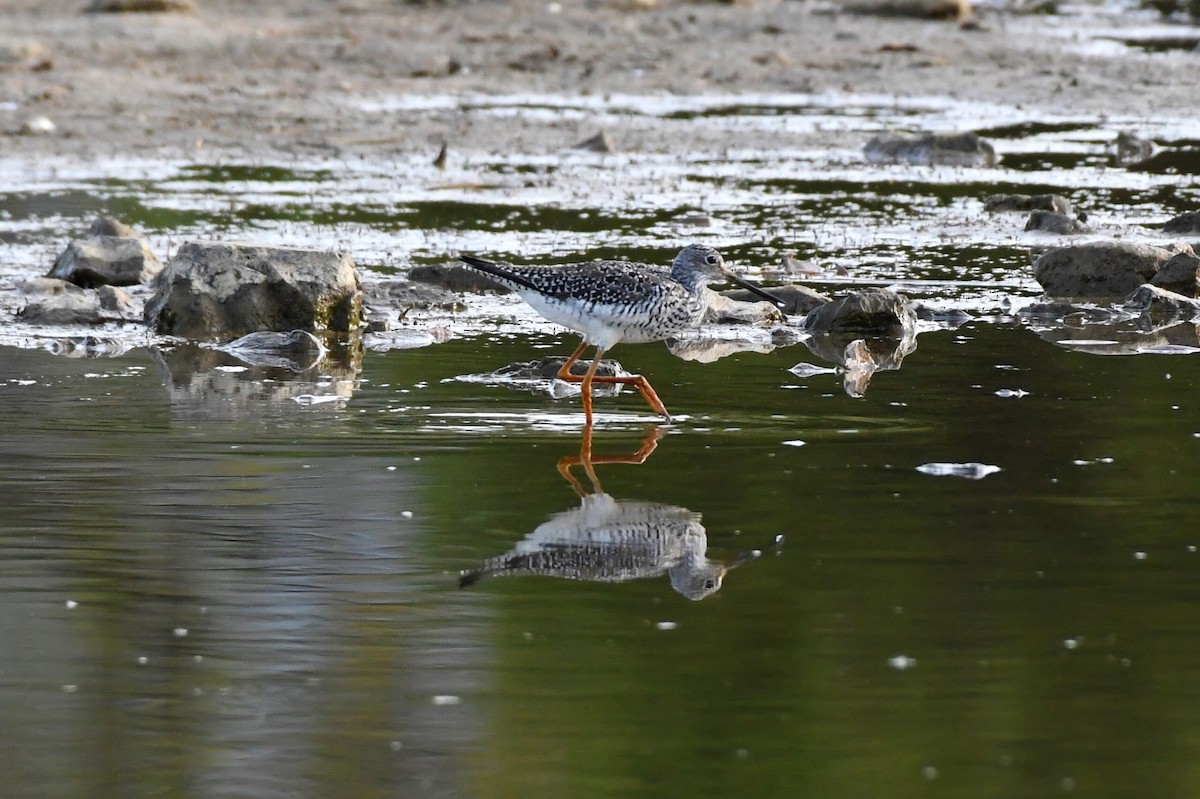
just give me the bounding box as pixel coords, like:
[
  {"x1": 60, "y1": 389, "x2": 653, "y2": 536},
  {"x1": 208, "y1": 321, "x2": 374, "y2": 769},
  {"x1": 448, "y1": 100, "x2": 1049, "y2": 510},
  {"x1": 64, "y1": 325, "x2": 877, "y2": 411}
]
[{"x1": 0, "y1": 324, "x2": 1200, "y2": 798}]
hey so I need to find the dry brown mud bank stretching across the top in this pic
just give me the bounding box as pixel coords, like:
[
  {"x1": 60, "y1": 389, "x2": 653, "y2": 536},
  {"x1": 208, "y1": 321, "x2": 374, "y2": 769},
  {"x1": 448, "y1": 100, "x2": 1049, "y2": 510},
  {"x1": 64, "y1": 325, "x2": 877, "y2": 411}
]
[{"x1": 0, "y1": 0, "x2": 1195, "y2": 162}]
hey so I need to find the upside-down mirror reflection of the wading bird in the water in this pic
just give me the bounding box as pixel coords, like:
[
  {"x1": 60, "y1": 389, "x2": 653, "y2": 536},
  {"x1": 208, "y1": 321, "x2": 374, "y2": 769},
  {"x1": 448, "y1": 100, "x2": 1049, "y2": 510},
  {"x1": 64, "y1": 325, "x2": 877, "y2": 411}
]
[{"x1": 458, "y1": 426, "x2": 761, "y2": 600}]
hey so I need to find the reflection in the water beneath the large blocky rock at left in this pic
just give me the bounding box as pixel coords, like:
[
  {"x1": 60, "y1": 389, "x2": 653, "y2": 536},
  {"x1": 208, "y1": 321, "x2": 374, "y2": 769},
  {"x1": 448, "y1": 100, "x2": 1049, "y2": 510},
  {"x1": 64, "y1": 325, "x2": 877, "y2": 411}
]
[{"x1": 151, "y1": 331, "x2": 362, "y2": 419}]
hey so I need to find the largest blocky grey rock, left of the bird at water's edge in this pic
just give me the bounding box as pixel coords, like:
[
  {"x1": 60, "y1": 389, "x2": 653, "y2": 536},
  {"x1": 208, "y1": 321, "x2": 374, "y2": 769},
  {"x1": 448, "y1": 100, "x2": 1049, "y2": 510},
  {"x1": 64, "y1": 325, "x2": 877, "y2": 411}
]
[{"x1": 145, "y1": 241, "x2": 362, "y2": 341}]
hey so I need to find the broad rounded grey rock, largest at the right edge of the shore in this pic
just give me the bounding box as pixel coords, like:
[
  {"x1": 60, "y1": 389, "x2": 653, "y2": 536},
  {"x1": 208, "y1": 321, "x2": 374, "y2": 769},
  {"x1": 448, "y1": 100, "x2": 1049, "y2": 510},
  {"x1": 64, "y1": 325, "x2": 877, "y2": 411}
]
[{"x1": 1033, "y1": 241, "x2": 1172, "y2": 299}]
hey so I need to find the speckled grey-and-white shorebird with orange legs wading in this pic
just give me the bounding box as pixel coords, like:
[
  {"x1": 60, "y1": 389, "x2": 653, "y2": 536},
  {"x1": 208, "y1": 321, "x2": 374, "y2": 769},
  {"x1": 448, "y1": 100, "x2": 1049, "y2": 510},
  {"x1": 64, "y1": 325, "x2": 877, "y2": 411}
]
[{"x1": 458, "y1": 245, "x2": 785, "y2": 427}]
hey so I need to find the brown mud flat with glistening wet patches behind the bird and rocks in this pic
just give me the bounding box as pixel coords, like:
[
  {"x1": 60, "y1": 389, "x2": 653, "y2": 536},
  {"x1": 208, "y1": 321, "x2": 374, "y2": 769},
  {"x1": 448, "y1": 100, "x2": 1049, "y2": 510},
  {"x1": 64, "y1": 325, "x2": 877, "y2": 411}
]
[{"x1": 0, "y1": 2, "x2": 1198, "y2": 369}]
